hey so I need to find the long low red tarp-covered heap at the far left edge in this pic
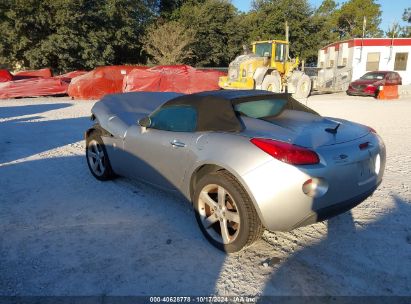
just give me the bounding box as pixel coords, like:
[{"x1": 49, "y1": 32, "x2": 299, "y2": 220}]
[{"x1": 0, "y1": 77, "x2": 68, "y2": 98}]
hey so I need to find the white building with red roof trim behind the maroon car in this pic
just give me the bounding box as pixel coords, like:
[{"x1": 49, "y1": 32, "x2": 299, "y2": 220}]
[{"x1": 314, "y1": 38, "x2": 411, "y2": 91}]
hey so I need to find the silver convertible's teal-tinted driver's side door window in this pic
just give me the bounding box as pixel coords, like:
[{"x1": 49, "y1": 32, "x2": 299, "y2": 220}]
[{"x1": 150, "y1": 105, "x2": 197, "y2": 132}]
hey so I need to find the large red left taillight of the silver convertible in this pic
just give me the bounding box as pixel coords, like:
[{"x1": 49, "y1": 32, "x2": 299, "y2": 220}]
[{"x1": 251, "y1": 138, "x2": 320, "y2": 165}]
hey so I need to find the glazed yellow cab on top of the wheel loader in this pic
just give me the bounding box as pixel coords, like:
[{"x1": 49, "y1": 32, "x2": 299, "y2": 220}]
[{"x1": 252, "y1": 40, "x2": 288, "y2": 74}]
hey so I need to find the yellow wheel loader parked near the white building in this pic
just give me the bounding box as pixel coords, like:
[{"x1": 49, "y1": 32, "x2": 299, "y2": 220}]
[{"x1": 218, "y1": 40, "x2": 311, "y2": 98}]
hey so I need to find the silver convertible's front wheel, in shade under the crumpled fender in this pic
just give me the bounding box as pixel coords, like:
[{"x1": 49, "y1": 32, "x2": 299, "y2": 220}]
[{"x1": 86, "y1": 132, "x2": 115, "y2": 181}]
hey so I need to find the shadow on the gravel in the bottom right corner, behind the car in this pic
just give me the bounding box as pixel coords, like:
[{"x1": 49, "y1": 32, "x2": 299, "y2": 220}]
[{"x1": 263, "y1": 195, "x2": 411, "y2": 296}]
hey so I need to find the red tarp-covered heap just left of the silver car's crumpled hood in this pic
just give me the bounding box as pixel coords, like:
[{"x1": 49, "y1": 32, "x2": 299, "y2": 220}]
[{"x1": 68, "y1": 66, "x2": 147, "y2": 99}]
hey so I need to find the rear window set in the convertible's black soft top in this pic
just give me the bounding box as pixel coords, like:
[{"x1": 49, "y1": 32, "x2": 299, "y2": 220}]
[{"x1": 234, "y1": 99, "x2": 287, "y2": 119}]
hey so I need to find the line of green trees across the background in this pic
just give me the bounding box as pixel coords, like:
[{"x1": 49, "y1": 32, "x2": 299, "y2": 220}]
[{"x1": 0, "y1": 0, "x2": 411, "y2": 72}]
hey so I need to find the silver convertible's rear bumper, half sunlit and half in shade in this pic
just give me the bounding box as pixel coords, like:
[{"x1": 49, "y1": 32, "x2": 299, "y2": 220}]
[{"x1": 242, "y1": 133, "x2": 386, "y2": 231}]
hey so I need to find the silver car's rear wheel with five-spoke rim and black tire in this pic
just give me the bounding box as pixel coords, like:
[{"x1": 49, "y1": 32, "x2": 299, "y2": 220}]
[{"x1": 193, "y1": 171, "x2": 264, "y2": 253}]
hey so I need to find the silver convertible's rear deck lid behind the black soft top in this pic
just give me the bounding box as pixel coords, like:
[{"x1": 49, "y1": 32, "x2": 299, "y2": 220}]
[{"x1": 243, "y1": 110, "x2": 370, "y2": 149}]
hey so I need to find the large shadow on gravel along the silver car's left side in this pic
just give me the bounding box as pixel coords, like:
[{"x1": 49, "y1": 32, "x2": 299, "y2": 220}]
[{"x1": 0, "y1": 156, "x2": 225, "y2": 295}]
